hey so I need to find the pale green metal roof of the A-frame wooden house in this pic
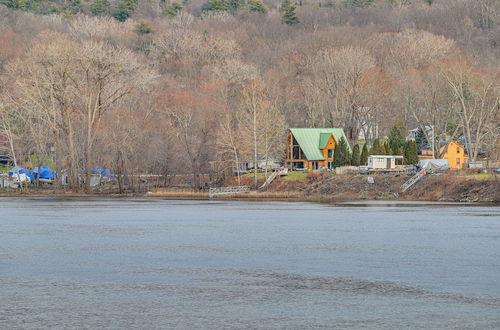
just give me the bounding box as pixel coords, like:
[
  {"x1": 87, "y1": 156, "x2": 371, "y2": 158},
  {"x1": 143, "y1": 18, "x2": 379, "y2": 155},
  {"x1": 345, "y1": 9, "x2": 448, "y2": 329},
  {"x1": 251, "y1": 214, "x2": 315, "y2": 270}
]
[{"x1": 290, "y1": 128, "x2": 351, "y2": 160}]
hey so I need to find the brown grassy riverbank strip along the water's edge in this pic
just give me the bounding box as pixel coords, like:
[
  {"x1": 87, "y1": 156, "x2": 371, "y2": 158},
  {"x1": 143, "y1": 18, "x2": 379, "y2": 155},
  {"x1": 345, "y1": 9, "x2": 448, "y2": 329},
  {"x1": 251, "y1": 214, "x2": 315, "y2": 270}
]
[{"x1": 0, "y1": 173, "x2": 500, "y2": 203}]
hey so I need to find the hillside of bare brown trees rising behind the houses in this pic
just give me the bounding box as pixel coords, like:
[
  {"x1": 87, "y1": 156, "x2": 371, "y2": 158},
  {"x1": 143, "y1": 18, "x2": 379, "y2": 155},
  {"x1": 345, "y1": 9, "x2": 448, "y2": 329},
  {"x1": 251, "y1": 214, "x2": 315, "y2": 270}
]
[{"x1": 0, "y1": 0, "x2": 500, "y2": 189}]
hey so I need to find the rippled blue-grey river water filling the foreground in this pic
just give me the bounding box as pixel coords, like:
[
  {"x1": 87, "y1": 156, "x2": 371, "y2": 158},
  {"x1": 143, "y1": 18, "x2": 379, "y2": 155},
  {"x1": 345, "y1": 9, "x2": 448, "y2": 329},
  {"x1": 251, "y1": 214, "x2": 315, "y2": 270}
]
[{"x1": 0, "y1": 198, "x2": 500, "y2": 329}]
